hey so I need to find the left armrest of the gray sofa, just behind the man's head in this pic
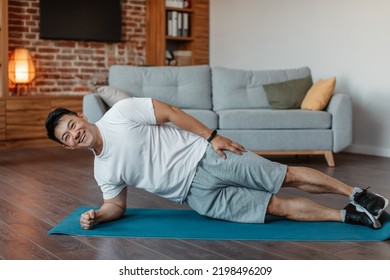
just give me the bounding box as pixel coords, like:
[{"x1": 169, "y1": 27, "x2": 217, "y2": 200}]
[{"x1": 83, "y1": 93, "x2": 108, "y2": 123}]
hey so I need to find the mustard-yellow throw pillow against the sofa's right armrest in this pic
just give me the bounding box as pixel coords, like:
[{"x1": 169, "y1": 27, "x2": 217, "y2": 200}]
[{"x1": 301, "y1": 77, "x2": 336, "y2": 111}]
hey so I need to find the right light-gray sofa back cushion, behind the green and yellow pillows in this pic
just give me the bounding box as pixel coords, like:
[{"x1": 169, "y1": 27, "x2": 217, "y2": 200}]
[{"x1": 212, "y1": 67, "x2": 311, "y2": 111}]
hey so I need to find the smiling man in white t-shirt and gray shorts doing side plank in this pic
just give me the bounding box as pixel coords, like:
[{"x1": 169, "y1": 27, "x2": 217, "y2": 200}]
[{"x1": 46, "y1": 98, "x2": 388, "y2": 229}]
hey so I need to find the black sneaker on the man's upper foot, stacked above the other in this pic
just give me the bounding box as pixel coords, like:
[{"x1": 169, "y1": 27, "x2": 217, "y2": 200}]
[{"x1": 351, "y1": 187, "x2": 389, "y2": 219}]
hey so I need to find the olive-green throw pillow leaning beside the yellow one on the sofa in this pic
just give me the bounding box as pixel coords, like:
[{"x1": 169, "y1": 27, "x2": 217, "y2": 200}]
[{"x1": 263, "y1": 76, "x2": 313, "y2": 109}]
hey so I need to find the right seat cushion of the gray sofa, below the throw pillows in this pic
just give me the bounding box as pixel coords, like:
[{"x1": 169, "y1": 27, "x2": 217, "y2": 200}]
[{"x1": 217, "y1": 109, "x2": 332, "y2": 129}]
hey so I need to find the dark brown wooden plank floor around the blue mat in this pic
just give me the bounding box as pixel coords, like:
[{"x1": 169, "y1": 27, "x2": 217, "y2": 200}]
[{"x1": 0, "y1": 147, "x2": 390, "y2": 260}]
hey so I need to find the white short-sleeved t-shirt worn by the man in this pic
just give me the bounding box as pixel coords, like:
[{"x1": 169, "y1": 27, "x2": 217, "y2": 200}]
[{"x1": 94, "y1": 98, "x2": 207, "y2": 203}]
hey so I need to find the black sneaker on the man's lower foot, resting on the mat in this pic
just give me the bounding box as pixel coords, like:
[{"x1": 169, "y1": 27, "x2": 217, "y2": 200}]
[{"x1": 344, "y1": 203, "x2": 382, "y2": 229}]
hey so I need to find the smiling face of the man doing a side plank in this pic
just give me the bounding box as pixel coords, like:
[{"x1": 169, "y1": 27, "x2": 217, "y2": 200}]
[{"x1": 54, "y1": 114, "x2": 95, "y2": 149}]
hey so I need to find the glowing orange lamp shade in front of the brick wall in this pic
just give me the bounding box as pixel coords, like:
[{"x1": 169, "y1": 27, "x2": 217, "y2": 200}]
[{"x1": 8, "y1": 48, "x2": 35, "y2": 84}]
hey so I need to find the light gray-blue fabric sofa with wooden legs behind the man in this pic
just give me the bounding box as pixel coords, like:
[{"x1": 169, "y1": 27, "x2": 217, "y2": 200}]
[{"x1": 83, "y1": 65, "x2": 352, "y2": 166}]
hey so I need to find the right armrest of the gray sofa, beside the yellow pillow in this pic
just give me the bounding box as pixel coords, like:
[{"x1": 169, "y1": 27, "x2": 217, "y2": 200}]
[{"x1": 326, "y1": 93, "x2": 352, "y2": 153}]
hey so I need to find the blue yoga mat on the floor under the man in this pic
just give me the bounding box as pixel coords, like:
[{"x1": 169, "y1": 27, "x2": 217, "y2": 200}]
[{"x1": 49, "y1": 207, "x2": 390, "y2": 241}]
